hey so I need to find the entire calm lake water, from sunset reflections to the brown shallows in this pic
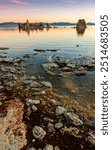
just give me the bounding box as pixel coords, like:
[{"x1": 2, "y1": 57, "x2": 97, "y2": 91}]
[{"x1": 0, "y1": 26, "x2": 95, "y2": 103}]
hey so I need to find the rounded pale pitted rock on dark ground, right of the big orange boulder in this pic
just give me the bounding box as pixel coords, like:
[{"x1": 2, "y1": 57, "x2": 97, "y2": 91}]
[{"x1": 32, "y1": 126, "x2": 46, "y2": 140}]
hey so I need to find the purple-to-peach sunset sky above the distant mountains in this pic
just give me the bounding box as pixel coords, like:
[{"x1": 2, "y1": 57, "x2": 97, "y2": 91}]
[{"x1": 0, "y1": 0, "x2": 95, "y2": 23}]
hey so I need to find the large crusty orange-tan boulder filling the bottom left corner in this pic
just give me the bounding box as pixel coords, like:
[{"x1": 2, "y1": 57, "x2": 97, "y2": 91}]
[{"x1": 0, "y1": 99, "x2": 27, "y2": 150}]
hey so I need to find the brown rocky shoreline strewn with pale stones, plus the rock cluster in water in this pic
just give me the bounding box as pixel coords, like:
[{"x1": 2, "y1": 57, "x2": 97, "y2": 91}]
[{"x1": 0, "y1": 51, "x2": 95, "y2": 150}]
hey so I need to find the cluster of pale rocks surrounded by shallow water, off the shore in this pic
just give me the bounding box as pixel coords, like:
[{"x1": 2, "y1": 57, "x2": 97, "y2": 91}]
[{"x1": 42, "y1": 56, "x2": 95, "y2": 77}]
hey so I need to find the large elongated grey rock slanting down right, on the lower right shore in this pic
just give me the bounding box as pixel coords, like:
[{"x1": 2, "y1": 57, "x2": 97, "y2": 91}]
[{"x1": 65, "y1": 112, "x2": 83, "y2": 125}]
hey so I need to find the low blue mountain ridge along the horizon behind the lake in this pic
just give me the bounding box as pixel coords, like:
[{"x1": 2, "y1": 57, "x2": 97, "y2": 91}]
[{"x1": 0, "y1": 22, "x2": 95, "y2": 27}]
